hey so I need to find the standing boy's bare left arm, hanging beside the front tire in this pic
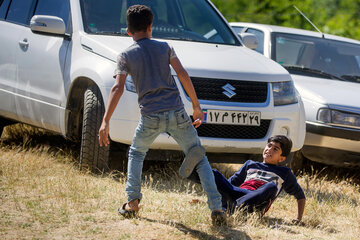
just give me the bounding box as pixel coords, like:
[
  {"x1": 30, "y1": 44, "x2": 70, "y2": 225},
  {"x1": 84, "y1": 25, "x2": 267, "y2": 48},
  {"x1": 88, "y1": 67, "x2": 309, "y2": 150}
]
[{"x1": 99, "y1": 74, "x2": 126, "y2": 147}]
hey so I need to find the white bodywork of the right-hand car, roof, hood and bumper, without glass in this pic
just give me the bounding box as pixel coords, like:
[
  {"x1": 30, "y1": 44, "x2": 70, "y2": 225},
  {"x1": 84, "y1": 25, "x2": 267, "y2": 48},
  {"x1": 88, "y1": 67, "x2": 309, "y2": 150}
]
[{"x1": 230, "y1": 22, "x2": 360, "y2": 166}]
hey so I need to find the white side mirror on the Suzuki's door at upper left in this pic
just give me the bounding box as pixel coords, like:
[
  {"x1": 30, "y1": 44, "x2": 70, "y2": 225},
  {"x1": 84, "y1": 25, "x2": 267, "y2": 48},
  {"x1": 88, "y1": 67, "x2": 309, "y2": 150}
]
[{"x1": 30, "y1": 15, "x2": 65, "y2": 35}]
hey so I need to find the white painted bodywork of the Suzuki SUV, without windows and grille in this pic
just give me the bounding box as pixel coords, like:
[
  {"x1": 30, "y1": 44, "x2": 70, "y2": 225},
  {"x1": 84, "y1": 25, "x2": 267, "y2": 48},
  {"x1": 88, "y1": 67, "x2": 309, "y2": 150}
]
[{"x1": 0, "y1": 0, "x2": 305, "y2": 161}]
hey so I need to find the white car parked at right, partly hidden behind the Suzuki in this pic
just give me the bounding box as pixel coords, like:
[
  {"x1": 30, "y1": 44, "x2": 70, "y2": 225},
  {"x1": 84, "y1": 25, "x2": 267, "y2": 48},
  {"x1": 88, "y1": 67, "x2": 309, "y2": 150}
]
[{"x1": 230, "y1": 22, "x2": 360, "y2": 167}]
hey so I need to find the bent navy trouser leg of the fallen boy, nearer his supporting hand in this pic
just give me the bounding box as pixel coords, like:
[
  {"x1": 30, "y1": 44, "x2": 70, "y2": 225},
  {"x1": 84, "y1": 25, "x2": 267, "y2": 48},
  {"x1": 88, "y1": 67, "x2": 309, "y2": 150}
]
[{"x1": 236, "y1": 182, "x2": 278, "y2": 212}]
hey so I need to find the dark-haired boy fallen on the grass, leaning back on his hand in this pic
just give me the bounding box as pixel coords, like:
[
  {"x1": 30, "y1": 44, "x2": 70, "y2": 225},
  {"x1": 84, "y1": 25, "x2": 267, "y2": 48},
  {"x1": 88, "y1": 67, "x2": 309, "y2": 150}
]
[{"x1": 204, "y1": 135, "x2": 305, "y2": 223}]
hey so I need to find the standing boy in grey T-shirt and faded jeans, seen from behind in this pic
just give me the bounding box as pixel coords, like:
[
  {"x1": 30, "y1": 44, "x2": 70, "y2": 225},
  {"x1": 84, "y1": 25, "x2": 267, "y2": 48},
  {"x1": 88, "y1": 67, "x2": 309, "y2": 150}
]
[{"x1": 99, "y1": 5, "x2": 226, "y2": 225}]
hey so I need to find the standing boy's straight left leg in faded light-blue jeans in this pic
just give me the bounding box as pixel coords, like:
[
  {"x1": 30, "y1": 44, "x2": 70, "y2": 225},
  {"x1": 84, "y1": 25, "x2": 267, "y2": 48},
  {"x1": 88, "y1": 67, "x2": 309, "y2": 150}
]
[{"x1": 126, "y1": 114, "x2": 160, "y2": 202}]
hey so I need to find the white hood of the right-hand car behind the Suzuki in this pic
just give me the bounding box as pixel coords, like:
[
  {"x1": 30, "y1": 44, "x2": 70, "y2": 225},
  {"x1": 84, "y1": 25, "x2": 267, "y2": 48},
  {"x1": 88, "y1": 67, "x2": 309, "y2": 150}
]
[{"x1": 291, "y1": 74, "x2": 360, "y2": 108}]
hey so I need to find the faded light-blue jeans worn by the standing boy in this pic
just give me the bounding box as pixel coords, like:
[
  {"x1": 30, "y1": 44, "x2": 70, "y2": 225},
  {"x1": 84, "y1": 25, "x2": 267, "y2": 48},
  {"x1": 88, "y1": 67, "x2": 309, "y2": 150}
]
[{"x1": 126, "y1": 108, "x2": 221, "y2": 210}]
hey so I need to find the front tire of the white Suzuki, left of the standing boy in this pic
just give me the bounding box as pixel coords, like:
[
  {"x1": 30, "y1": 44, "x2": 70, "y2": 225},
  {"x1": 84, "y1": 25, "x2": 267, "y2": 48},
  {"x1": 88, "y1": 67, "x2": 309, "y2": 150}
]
[{"x1": 80, "y1": 85, "x2": 110, "y2": 172}]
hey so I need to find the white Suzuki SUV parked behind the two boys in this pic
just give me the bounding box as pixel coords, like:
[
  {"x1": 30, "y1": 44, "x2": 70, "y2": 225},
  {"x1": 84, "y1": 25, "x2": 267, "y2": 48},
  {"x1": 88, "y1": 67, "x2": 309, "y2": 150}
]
[{"x1": 0, "y1": 0, "x2": 305, "y2": 169}]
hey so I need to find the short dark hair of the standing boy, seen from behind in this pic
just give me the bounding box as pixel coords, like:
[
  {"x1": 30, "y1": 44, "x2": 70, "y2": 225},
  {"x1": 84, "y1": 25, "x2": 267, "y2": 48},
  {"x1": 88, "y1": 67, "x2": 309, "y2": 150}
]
[{"x1": 126, "y1": 5, "x2": 154, "y2": 34}]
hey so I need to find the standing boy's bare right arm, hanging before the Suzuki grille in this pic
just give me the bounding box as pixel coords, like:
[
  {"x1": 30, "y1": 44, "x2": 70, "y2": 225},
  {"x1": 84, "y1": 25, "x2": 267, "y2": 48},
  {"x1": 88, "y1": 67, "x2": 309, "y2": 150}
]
[{"x1": 170, "y1": 57, "x2": 204, "y2": 128}]
